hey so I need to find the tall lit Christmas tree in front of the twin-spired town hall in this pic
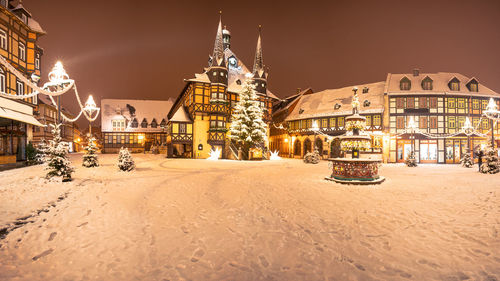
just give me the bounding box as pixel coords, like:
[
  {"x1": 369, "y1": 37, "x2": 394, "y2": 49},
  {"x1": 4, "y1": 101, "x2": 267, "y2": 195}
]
[{"x1": 230, "y1": 78, "x2": 267, "y2": 151}]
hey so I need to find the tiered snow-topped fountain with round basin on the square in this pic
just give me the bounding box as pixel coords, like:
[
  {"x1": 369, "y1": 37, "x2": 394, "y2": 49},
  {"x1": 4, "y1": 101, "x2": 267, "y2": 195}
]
[{"x1": 326, "y1": 87, "x2": 385, "y2": 184}]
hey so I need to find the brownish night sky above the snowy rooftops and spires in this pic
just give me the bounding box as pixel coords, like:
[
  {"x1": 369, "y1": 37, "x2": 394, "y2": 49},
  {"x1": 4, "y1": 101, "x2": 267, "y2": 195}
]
[{"x1": 23, "y1": 0, "x2": 500, "y2": 124}]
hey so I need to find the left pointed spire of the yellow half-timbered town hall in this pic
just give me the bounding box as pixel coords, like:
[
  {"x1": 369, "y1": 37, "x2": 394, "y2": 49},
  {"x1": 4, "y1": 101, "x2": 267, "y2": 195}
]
[{"x1": 207, "y1": 13, "x2": 227, "y2": 87}]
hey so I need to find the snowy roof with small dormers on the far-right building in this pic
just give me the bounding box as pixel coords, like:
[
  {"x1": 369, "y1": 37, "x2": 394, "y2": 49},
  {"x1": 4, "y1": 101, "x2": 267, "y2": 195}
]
[{"x1": 386, "y1": 72, "x2": 500, "y2": 97}]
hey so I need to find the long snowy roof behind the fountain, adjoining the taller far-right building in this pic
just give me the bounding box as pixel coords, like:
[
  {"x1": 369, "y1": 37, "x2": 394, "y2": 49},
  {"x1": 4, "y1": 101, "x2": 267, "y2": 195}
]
[{"x1": 286, "y1": 82, "x2": 385, "y2": 121}]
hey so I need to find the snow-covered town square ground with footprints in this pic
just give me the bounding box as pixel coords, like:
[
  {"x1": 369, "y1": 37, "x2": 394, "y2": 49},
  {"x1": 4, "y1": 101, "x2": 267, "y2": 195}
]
[{"x1": 0, "y1": 154, "x2": 500, "y2": 280}]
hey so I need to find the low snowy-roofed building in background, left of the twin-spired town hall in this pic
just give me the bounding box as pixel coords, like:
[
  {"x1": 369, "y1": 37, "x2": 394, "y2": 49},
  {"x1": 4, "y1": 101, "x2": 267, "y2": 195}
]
[{"x1": 101, "y1": 99, "x2": 172, "y2": 153}]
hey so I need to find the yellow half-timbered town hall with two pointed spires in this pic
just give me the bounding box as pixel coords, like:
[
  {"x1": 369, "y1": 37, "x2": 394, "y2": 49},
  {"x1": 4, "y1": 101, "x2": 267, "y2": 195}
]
[{"x1": 168, "y1": 18, "x2": 279, "y2": 158}]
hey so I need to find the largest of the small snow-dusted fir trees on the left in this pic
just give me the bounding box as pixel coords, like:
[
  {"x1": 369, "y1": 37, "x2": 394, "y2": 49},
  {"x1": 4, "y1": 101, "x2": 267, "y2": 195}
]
[{"x1": 45, "y1": 124, "x2": 75, "y2": 181}]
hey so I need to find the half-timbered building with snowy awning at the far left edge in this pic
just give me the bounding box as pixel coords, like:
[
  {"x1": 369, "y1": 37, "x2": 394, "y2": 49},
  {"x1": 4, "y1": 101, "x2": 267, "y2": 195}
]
[{"x1": 0, "y1": 0, "x2": 45, "y2": 164}]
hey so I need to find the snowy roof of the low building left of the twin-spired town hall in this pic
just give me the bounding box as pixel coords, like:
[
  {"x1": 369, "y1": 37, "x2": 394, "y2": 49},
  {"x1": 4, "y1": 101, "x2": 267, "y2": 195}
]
[{"x1": 101, "y1": 99, "x2": 173, "y2": 132}]
